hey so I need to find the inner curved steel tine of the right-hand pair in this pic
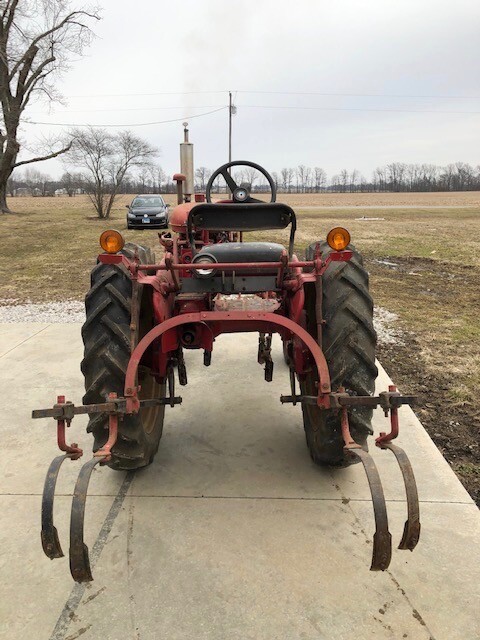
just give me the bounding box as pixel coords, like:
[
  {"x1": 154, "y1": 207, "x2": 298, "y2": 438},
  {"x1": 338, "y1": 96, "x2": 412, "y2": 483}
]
[{"x1": 347, "y1": 448, "x2": 392, "y2": 571}]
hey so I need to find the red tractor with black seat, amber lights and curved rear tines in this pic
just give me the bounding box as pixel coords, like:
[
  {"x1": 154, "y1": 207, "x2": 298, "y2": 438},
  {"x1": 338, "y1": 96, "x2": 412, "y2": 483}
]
[{"x1": 33, "y1": 162, "x2": 420, "y2": 582}]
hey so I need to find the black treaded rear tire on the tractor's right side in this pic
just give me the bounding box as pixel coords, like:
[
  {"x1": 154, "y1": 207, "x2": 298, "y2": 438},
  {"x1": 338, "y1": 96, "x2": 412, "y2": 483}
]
[{"x1": 300, "y1": 242, "x2": 378, "y2": 465}]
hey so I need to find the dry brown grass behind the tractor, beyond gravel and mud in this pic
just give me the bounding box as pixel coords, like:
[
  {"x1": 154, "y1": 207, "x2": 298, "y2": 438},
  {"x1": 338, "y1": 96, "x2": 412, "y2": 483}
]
[{"x1": 0, "y1": 194, "x2": 480, "y2": 301}]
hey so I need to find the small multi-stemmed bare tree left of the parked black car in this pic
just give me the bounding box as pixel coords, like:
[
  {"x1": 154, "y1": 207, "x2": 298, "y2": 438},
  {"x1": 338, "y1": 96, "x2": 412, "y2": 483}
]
[{"x1": 66, "y1": 127, "x2": 157, "y2": 218}]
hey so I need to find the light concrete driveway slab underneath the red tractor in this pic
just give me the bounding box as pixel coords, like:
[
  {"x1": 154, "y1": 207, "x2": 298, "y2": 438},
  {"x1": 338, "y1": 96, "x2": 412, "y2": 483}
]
[{"x1": 0, "y1": 324, "x2": 480, "y2": 640}]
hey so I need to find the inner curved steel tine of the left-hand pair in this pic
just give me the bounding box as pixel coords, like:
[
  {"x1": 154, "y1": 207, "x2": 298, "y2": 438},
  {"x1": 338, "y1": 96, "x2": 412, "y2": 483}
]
[{"x1": 70, "y1": 456, "x2": 105, "y2": 582}]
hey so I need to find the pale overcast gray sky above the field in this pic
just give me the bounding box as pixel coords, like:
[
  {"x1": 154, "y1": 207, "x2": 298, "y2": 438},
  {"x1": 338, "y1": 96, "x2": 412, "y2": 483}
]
[{"x1": 23, "y1": 0, "x2": 480, "y2": 178}]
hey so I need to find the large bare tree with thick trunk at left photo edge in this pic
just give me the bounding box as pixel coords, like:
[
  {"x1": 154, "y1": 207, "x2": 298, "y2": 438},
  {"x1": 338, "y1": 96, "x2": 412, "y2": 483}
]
[{"x1": 0, "y1": 0, "x2": 99, "y2": 213}]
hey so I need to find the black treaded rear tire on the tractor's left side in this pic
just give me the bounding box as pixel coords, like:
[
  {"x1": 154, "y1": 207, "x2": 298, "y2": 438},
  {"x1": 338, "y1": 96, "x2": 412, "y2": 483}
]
[{"x1": 81, "y1": 243, "x2": 166, "y2": 470}]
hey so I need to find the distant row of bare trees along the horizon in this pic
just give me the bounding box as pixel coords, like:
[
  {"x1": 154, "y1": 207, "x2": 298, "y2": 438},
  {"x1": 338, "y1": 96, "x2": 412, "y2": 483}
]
[{"x1": 7, "y1": 158, "x2": 480, "y2": 202}]
